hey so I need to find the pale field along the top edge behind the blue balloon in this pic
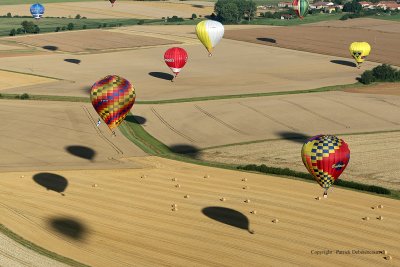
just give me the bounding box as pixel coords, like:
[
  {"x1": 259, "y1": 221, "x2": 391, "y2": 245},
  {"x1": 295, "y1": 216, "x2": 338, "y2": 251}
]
[{"x1": 1, "y1": 1, "x2": 214, "y2": 19}]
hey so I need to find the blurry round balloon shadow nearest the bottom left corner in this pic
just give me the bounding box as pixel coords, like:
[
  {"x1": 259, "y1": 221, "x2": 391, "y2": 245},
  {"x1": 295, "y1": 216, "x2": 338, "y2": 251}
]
[{"x1": 48, "y1": 217, "x2": 88, "y2": 241}]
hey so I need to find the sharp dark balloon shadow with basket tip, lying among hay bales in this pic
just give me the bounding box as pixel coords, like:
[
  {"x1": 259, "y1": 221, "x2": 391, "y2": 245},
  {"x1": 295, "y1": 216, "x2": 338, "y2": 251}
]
[{"x1": 201, "y1": 207, "x2": 252, "y2": 233}]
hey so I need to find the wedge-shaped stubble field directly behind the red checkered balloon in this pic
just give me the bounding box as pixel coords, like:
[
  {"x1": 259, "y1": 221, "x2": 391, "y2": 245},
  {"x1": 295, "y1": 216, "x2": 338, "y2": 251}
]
[{"x1": 200, "y1": 130, "x2": 400, "y2": 190}]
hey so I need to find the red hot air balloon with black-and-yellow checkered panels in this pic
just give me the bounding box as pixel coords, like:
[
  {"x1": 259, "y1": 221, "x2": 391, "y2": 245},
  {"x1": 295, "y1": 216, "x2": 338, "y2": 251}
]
[{"x1": 301, "y1": 135, "x2": 350, "y2": 197}]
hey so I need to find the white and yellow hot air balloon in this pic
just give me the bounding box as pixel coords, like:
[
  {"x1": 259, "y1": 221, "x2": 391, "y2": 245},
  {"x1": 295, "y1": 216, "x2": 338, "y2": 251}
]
[{"x1": 196, "y1": 20, "x2": 224, "y2": 56}]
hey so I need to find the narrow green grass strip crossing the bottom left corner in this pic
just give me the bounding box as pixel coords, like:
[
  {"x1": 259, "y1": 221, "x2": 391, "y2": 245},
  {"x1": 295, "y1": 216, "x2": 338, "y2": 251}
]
[{"x1": 0, "y1": 224, "x2": 89, "y2": 267}]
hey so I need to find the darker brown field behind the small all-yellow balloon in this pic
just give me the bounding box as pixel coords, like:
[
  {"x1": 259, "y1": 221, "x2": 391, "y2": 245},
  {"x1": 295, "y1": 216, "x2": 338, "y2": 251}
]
[{"x1": 224, "y1": 20, "x2": 400, "y2": 66}]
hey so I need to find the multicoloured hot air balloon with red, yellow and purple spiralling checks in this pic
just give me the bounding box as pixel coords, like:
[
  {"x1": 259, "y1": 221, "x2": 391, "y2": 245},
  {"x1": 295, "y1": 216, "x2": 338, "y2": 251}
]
[{"x1": 90, "y1": 75, "x2": 136, "y2": 135}]
